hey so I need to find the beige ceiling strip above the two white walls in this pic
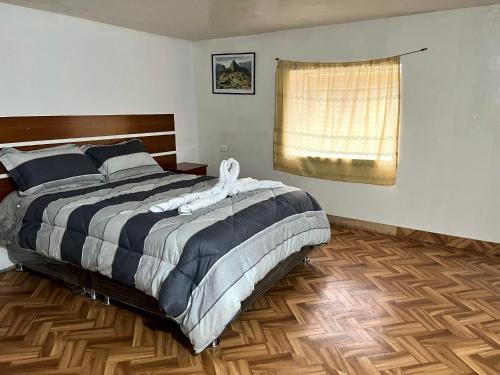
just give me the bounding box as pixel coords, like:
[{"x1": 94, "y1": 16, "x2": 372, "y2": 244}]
[{"x1": 3, "y1": 0, "x2": 500, "y2": 40}]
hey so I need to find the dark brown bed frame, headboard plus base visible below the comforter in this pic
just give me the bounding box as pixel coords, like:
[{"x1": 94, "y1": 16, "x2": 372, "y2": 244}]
[{"x1": 0, "y1": 114, "x2": 312, "y2": 352}]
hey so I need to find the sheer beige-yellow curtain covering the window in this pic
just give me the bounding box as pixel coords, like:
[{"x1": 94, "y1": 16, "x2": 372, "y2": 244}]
[{"x1": 274, "y1": 56, "x2": 400, "y2": 185}]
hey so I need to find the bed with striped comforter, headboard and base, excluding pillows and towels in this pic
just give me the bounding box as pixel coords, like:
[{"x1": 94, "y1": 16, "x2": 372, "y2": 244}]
[{"x1": 0, "y1": 114, "x2": 330, "y2": 353}]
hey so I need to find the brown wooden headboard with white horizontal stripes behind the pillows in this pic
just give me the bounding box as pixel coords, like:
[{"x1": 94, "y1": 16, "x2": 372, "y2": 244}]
[{"x1": 0, "y1": 114, "x2": 177, "y2": 200}]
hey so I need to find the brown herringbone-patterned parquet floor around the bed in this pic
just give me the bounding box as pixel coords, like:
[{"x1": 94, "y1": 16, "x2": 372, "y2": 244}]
[{"x1": 0, "y1": 228, "x2": 500, "y2": 375}]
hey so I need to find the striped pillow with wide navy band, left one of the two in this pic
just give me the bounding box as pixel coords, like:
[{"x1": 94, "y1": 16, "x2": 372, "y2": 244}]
[{"x1": 0, "y1": 144, "x2": 105, "y2": 195}]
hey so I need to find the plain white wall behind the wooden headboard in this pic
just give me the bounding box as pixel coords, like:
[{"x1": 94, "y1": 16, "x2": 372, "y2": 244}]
[{"x1": 0, "y1": 4, "x2": 199, "y2": 269}]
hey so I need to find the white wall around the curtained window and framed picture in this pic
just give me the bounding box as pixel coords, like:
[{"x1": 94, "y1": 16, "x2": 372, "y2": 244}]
[{"x1": 194, "y1": 6, "x2": 500, "y2": 242}]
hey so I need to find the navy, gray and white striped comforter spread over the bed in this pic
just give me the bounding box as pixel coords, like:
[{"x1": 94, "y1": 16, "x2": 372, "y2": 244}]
[{"x1": 0, "y1": 172, "x2": 330, "y2": 352}]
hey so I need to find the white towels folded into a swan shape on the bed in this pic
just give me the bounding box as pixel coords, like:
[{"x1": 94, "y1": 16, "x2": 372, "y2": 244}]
[{"x1": 149, "y1": 158, "x2": 285, "y2": 215}]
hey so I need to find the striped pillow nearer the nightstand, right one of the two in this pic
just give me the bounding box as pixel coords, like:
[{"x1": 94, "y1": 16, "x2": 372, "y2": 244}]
[{"x1": 82, "y1": 139, "x2": 163, "y2": 182}]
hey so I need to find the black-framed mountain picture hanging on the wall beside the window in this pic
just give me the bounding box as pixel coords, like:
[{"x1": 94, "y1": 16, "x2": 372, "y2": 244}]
[{"x1": 212, "y1": 52, "x2": 255, "y2": 95}]
